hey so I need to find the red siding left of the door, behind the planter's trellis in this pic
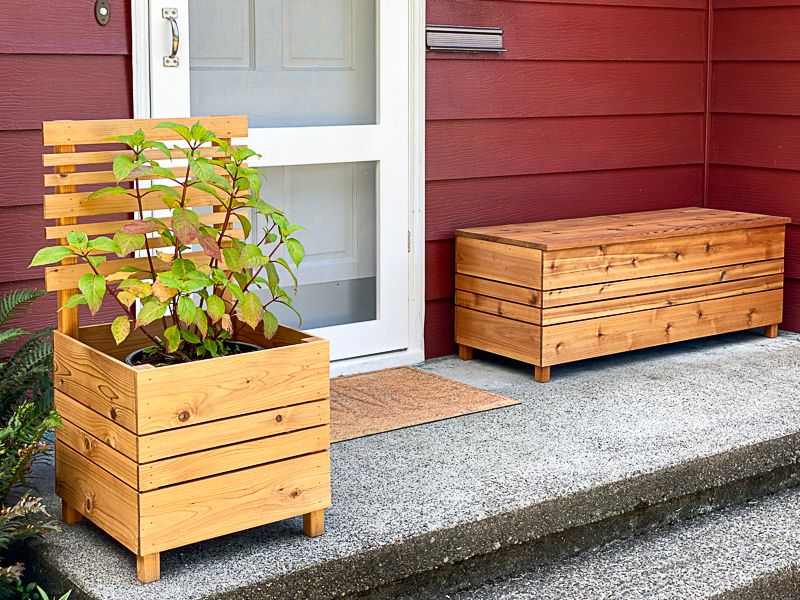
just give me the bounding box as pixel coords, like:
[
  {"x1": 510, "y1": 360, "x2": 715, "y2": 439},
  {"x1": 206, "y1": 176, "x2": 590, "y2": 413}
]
[{"x1": 0, "y1": 0, "x2": 133, "y2": 329}]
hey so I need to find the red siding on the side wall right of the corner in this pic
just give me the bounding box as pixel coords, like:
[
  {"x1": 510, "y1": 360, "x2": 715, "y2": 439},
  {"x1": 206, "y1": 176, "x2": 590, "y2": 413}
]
[{"x1": 708, "y1": 0, "x2": 800, "y2": 331}]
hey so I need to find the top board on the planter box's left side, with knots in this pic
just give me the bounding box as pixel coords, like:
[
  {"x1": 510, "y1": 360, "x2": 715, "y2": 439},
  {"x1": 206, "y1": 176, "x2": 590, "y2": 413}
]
[{"x1": 53, "y1": 331, "x2": 137, "y2": 432}]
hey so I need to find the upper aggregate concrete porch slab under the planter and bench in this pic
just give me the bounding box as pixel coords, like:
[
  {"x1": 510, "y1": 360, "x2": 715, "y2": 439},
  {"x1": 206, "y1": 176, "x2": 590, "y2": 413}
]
[{"x1": 25, "y1": 330, "x2": 800, "y2": 600}]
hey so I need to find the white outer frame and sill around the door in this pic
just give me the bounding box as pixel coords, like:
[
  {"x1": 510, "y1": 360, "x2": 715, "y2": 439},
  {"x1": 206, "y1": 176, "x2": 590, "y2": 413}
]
[{"x1": 131, "y1": 0, "x2": 425, "y2": 377}]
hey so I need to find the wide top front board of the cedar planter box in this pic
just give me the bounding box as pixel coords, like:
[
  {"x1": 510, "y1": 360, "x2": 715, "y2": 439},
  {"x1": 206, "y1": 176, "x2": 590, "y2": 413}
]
[{"x1": 136, "y1": 340, "x2": 330, "y2": 435}]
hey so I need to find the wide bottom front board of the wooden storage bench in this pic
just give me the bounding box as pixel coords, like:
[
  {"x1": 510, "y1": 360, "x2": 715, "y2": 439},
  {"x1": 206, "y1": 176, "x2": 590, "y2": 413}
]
[{"x1": 540, "y1": 290, "x2": 783, "y2": 365}]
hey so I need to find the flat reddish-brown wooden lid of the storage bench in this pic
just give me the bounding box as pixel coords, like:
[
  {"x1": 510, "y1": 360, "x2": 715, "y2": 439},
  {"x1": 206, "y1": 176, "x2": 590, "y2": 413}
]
[{"x1": 456, "y1": 207, "x2": 789, "y2": 251}]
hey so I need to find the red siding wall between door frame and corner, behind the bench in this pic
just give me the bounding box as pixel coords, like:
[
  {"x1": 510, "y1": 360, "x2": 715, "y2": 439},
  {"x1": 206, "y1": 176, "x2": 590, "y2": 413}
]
[{"x1": 425, "y1": 0, "x2": 708, "y2": 357}]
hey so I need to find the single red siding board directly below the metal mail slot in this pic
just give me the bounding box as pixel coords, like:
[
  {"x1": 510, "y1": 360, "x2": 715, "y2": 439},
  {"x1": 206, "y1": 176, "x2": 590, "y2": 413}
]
[{"x1": 425, "y1": 60, "x2": 704, "y2": 120}]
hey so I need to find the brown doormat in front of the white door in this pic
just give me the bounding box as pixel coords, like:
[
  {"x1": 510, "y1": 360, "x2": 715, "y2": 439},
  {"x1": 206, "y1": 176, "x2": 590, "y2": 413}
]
[{"x1": 331, "y1": 367, "x2": 519, "y2": 442}]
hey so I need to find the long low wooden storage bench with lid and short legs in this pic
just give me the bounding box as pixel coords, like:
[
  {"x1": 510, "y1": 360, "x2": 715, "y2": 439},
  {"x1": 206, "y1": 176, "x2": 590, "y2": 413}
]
[{"x1": 455, "y1": 208, "x2": 789, "y2": 382}]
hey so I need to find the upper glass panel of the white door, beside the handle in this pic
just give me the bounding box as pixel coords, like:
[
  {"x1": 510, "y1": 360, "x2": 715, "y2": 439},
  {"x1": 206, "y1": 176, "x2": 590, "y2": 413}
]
[{"x1": 189, "y1": 0, "x2": 377, "y2": 127}]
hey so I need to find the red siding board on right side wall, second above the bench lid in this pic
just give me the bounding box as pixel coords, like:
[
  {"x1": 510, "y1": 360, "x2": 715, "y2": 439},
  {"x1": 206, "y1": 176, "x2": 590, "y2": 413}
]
[{"x1": 709, "y1": 114, "x2": 800, "y2": 170}]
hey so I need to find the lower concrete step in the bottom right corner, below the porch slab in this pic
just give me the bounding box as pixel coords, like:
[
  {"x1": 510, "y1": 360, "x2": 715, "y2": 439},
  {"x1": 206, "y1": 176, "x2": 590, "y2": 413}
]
[{"x1": 448, "y1": 489, "x2": 800, "y2": 600}]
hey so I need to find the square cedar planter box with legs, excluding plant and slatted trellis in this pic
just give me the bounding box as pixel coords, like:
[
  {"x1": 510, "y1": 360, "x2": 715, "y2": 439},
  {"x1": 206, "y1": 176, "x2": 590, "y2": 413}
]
[{"x1": 54, "y1": 325, "x2": 331, "y2": 582}]
